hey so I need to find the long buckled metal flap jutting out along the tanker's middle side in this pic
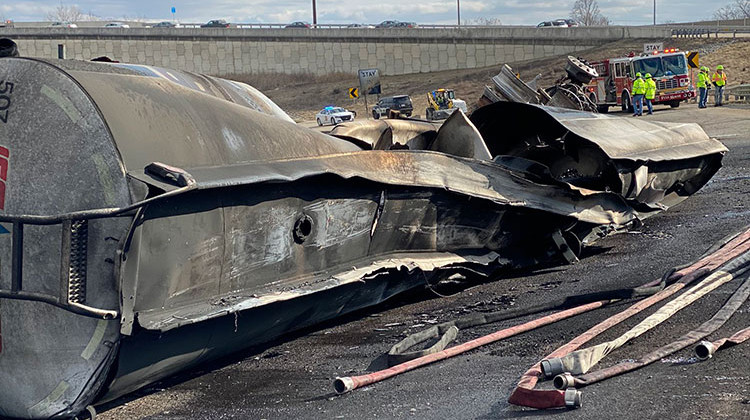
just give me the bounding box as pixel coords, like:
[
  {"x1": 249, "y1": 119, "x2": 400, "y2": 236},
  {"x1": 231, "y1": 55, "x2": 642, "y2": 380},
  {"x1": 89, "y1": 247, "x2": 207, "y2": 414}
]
[{"x1": 156, "y1": 151, "x2": 636, "y2": 225}]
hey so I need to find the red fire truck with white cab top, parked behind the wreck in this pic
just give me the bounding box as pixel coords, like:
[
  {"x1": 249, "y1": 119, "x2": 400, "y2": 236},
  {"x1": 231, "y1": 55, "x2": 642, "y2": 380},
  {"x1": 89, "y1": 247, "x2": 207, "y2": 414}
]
[{"x1": 586, "y1": 48, "x2": 695, "y2": 113}]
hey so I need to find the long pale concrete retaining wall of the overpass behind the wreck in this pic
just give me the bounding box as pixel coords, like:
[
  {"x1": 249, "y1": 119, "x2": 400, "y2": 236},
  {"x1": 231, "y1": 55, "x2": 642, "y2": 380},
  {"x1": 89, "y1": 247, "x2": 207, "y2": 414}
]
[{"x1": 0, "y1": 26, "x2": 671, "y2": 76}]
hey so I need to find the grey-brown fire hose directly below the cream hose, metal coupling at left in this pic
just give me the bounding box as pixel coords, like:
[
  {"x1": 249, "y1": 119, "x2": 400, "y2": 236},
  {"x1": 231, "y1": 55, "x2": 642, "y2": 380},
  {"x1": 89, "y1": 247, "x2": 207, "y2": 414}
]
[{"x1": 553, "y1": 270, "x2": 750, "y2": 389}]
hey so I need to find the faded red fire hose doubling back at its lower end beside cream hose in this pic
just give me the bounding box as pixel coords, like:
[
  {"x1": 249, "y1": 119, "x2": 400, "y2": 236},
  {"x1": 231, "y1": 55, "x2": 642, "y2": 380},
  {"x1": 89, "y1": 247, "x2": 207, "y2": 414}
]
[{"x1": 508, "y1": 225, "x2": 750, "y2": 409}]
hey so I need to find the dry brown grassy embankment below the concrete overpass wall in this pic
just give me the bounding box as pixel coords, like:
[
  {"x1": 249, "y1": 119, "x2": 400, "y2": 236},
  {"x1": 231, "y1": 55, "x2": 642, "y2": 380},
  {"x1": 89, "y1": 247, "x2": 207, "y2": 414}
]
[{"x1": 231, "y1": 38, "x2": 750, "y2": 121}]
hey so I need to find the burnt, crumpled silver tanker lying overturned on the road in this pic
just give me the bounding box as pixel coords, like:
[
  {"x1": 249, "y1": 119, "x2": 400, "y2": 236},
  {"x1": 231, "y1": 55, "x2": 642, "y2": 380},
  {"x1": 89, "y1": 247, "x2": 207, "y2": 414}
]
[{"x1": 0, "y1": 58, "x2": 725, "y2": 418}]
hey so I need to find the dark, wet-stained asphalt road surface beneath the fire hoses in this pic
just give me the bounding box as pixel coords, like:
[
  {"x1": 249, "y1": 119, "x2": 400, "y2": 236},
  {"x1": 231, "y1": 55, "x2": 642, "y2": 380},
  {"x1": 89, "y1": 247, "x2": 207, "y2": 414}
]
[{"x1": 99, "y1": 104, "x2": 750, "y2": 419}]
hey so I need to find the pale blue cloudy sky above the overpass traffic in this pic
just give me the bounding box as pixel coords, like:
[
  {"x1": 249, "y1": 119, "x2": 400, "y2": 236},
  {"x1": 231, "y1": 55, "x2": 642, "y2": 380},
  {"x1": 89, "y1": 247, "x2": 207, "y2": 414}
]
[{"x1": 0, "y1": 0, "x2": 730, "y2": 25}]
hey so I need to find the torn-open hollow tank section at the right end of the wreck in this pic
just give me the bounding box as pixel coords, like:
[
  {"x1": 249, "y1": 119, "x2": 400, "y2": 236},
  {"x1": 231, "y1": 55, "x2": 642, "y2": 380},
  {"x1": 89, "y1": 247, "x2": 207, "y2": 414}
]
[{"x1": 471, "y1": 102, "x2": 727, "y2": 213}]
